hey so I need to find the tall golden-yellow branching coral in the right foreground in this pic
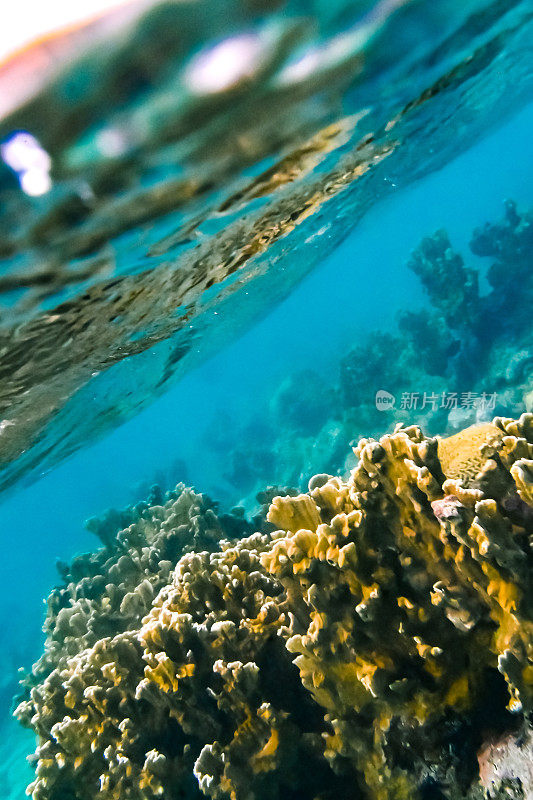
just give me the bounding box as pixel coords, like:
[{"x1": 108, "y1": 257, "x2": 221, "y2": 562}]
[{"x1": 263, "y1": 416, "x2": 533, "y2": 799}]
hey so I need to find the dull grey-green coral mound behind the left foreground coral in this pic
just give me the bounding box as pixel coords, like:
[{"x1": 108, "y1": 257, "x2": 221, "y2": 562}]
[{"x1": 21, "y1": 484, "x2": 260, "y2": 690}]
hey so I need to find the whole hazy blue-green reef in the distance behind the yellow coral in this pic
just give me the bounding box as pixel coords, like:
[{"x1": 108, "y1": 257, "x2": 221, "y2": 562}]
[{"x1": 216, "y1": 201, "x2": 533, "y2": 504}]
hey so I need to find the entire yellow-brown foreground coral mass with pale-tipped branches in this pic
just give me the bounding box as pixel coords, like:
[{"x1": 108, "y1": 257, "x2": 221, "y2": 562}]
[{"x1": 16, "y1": 414, "x2": 533, "y2": 800}]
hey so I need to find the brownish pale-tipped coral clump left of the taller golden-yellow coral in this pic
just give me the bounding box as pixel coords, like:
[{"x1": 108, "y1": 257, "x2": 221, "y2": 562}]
[{"x1": 18, "y1": 534, "x2": 341, "y2": 800}]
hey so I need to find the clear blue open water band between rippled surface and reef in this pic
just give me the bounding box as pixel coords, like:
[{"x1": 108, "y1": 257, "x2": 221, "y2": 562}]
[{"x1": 0, "y1": 1, "x2": 533, "y2": 800}]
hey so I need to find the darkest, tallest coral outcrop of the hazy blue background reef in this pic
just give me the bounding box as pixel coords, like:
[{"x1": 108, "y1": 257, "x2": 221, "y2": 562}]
[{"x1": 341, "y1": 201, "x2": 533, "y2": 418}]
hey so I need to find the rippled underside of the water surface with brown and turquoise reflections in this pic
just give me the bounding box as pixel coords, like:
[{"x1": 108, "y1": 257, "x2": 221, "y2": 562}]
[{"x1": 0, "y1": 0, "x2": 533, "y2": 496}]
